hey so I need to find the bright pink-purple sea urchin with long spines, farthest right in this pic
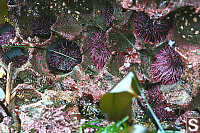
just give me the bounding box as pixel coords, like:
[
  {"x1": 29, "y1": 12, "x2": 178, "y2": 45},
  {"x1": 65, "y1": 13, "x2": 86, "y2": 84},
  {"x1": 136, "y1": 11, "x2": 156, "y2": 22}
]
[{"x1": 150, "y1": 47, "x2": 184, "y2": 85}]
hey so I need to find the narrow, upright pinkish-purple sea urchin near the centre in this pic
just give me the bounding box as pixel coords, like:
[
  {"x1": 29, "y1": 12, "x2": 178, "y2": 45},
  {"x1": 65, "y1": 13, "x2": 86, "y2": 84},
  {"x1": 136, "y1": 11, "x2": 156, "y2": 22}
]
[{"x1": 90, "y1": 31, "x2": 111, "y2": 69}]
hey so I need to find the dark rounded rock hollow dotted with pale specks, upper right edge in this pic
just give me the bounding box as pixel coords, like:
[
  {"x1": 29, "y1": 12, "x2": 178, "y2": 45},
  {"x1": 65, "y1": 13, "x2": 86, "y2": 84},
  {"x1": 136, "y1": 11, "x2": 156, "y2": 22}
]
[{"x1": 174, "y1": 6, "x2": 200, "y2": 44}]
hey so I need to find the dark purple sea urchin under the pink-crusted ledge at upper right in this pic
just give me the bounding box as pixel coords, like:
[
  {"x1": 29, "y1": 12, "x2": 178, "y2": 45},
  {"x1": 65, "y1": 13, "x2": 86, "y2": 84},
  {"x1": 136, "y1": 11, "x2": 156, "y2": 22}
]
[{"x1": 133, "y1": 12, "x2": 171, "y2": 44}]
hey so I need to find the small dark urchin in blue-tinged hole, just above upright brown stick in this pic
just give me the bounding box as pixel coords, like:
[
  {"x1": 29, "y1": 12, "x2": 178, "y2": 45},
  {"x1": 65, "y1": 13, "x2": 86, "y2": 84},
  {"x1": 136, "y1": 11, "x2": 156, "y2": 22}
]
[{"x1": 4, "y1": 48, "x2": 28, "y2": 68}]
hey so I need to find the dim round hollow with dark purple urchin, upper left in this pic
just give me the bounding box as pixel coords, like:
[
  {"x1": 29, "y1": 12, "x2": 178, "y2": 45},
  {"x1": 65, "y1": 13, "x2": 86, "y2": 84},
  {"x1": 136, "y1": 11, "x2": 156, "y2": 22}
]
[{"x1": 16, "y1": 0, "x2": 56, "y2": 42}]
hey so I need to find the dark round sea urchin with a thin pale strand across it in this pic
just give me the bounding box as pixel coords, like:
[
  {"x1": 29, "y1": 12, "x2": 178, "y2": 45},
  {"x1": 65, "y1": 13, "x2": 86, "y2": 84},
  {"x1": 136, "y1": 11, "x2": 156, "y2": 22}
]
[{"x1": 46, "y1": 39, "x2": 82, "y2": 74}]
